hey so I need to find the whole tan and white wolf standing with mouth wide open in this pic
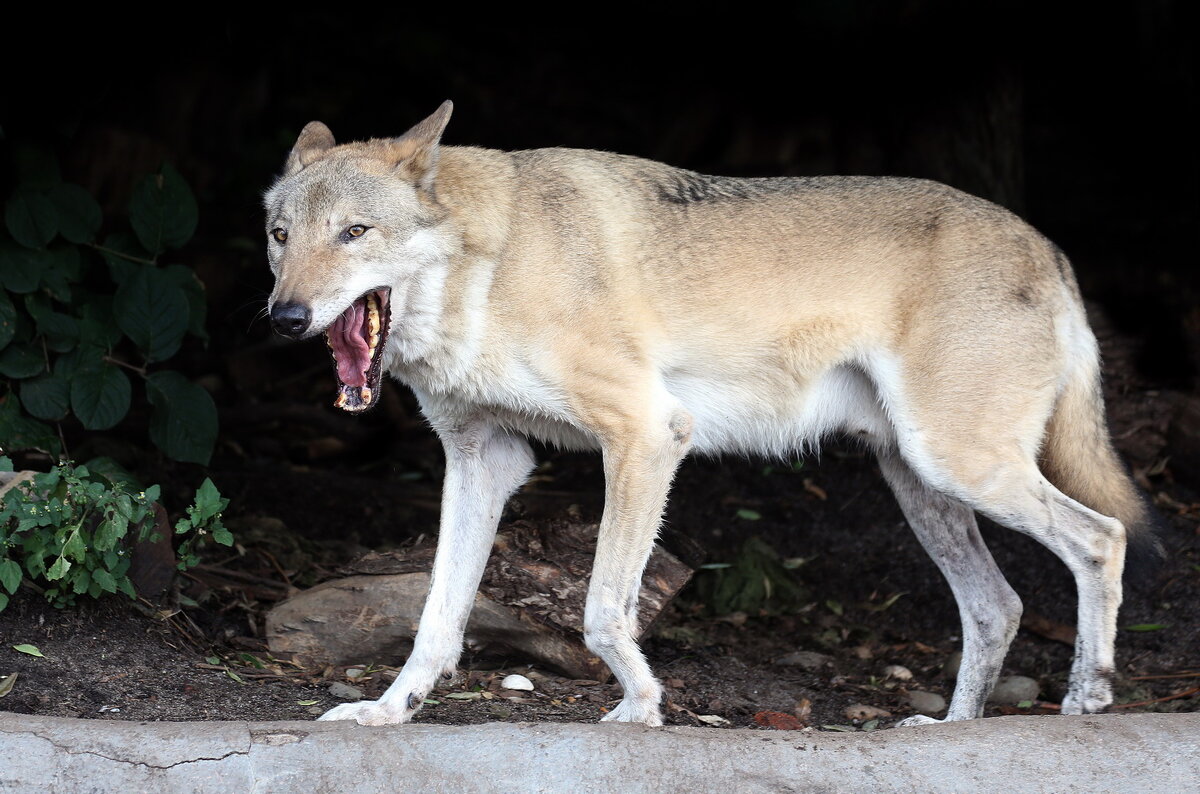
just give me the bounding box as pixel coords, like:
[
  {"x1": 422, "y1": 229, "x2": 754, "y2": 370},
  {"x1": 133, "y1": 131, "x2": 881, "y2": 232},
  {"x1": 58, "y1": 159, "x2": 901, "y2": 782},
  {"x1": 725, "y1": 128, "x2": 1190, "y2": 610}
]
[{"x1": 264, "y1": 102, "x2": 1147, "y2": 726}]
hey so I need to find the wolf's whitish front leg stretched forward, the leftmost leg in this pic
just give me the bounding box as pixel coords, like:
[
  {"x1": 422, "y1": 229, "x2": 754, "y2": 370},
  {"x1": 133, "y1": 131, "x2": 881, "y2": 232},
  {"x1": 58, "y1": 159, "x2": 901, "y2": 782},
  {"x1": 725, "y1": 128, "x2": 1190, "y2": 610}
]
[{"x1": 320, "y1": 421, "x2": 534, "y2": 726}]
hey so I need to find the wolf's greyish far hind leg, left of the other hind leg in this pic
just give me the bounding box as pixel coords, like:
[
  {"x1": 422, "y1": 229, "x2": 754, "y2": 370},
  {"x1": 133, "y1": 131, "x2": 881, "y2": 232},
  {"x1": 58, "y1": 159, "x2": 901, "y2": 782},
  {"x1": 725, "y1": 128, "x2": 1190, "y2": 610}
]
[{"x1": 880, "y1": 452, "x2": 1021, "y2": 724}]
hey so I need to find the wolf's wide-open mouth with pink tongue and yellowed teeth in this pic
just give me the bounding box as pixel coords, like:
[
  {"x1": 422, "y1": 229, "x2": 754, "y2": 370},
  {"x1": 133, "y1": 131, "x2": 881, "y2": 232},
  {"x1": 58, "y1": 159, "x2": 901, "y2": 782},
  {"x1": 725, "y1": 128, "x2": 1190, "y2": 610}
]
[{"x1": 325, "y1": 287, "x2": 391, "y2": 414}]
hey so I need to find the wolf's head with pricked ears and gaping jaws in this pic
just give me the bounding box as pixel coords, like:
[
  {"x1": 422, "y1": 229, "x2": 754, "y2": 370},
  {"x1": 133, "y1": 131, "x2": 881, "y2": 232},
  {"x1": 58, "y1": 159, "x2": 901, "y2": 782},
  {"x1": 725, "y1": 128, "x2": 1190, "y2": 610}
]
[{"x1": 264, "y1": 101, "x2": 454, "y2": 411}]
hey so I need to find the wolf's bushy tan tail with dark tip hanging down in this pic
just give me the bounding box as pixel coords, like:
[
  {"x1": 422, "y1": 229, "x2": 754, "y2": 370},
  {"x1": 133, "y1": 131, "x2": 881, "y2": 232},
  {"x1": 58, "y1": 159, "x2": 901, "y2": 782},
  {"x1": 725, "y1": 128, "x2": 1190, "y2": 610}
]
[{"x1": 1040, "y1": 329, "x2": 1163, "y2": 576}]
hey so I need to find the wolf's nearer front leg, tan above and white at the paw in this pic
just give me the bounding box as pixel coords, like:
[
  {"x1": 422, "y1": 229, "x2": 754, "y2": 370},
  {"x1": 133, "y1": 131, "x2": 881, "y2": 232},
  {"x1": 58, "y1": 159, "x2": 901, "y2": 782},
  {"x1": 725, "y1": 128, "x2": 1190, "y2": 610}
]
[{"x1": 583, "y1": 411, "x2": 691, "y2": 726}]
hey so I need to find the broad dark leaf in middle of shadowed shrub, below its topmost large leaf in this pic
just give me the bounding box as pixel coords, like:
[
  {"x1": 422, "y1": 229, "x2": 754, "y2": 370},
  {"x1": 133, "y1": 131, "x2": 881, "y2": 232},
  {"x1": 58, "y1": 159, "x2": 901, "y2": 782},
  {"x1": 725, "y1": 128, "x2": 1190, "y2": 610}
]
[{"x1": 113, "y1": 265, "x2": 188, "y2": 361}]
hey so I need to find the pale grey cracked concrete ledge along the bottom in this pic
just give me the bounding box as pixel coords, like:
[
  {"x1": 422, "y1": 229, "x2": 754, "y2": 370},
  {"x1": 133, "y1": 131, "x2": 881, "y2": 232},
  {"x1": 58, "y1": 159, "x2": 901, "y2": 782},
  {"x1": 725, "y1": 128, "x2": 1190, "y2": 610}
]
[{"x1": 0, "y1": 712, "x2": 1200, "y2": 794}]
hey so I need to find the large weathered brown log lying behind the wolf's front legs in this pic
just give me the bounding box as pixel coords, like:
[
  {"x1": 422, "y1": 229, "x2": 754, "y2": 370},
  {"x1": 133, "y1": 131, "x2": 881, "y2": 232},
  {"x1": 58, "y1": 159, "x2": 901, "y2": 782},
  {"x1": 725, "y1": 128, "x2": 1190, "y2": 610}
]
[{"x1": 265, "y1": 521, "x2": 691, "y2": 681}]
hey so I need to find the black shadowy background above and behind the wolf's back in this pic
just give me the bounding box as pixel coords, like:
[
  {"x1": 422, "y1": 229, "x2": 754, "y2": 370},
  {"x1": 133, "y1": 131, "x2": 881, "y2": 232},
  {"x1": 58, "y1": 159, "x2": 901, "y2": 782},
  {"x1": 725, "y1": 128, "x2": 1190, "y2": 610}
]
[{"x1": 0, "y1": 0, "x2": 1200, "y2": 474}]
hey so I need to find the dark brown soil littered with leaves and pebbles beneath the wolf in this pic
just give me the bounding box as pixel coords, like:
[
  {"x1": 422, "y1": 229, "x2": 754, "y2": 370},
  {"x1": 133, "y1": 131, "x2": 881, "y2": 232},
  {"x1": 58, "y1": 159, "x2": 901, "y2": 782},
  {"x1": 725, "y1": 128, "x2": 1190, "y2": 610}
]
[{"x1": 0, "y1": 307, "x2": 1200, "y2": 730}]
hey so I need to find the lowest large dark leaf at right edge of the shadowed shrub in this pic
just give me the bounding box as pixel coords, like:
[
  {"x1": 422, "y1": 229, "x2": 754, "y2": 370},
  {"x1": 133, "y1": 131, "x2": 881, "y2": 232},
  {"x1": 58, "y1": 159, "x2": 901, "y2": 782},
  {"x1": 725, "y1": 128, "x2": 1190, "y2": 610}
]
[{"x1": 146, "y1": 369, "x2": 217, "y2": 467}]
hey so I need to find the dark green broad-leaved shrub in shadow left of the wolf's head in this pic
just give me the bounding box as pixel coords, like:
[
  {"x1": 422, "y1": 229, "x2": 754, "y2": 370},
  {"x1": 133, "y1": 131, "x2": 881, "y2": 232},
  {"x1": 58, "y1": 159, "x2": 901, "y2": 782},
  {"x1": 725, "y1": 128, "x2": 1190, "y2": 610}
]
[{"x1": 0, "y1": 148, "x2": 217, "y2": 463}]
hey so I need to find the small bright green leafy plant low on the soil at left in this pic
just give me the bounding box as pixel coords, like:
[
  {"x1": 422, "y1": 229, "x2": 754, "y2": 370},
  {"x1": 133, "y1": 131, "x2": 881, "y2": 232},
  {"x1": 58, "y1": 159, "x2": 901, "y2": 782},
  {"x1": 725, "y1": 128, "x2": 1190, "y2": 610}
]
[{"x1": 0, "y1": 457, "x2": 233, "y2": 610}]
